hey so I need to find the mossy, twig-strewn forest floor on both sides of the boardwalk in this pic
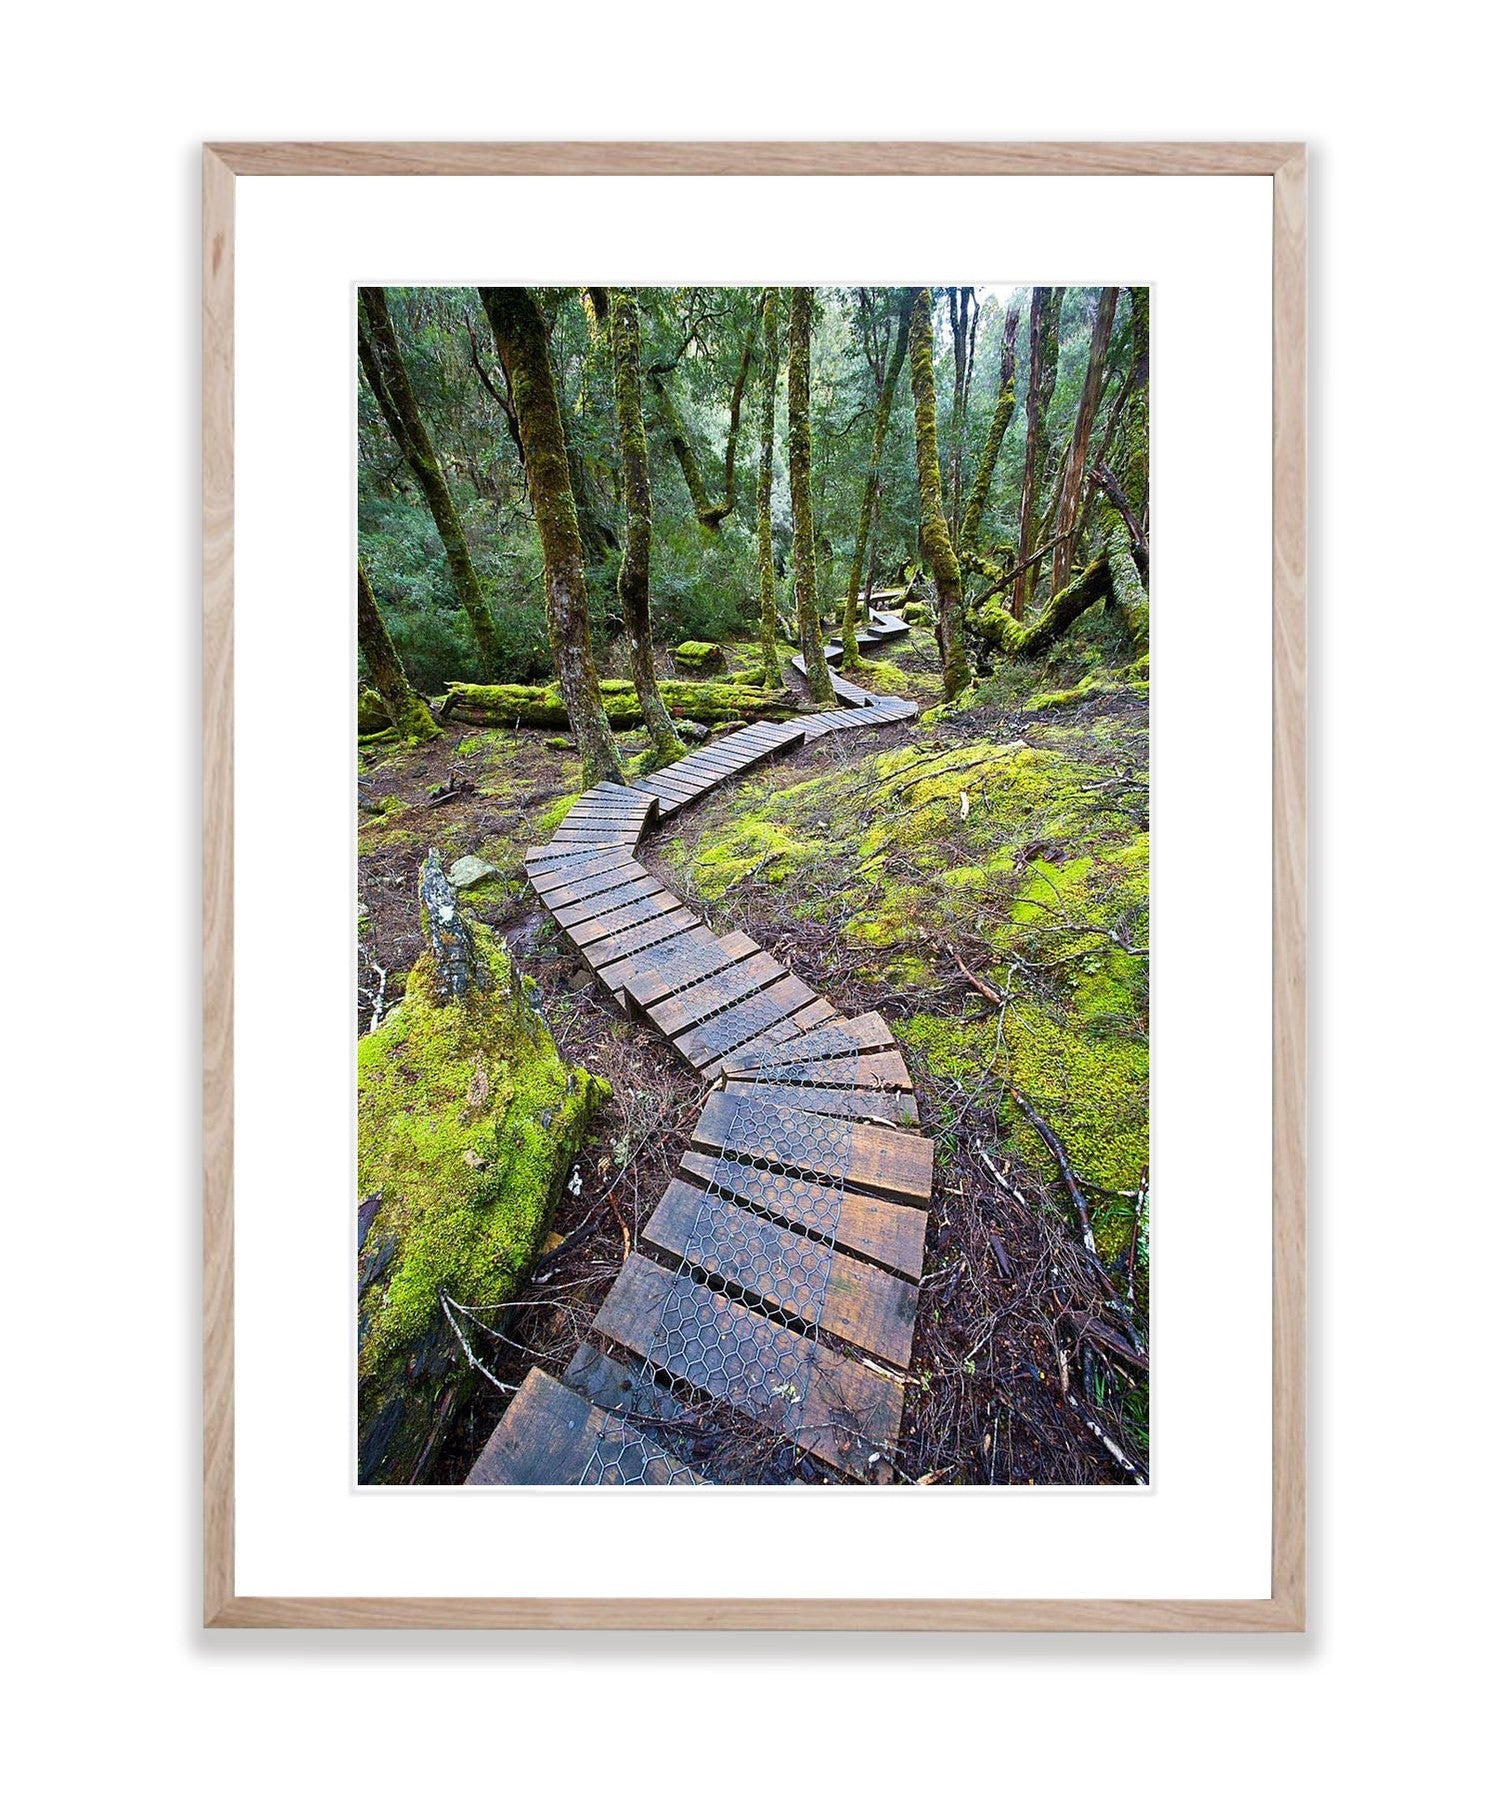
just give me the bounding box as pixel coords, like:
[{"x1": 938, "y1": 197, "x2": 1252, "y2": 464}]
[{"x1": 360, "y1": 608, "x2": 1148, "y2": 1481}]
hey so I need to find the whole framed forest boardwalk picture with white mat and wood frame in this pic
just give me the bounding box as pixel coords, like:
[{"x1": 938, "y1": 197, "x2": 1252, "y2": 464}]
[{"x1": 203, "y1": 144, "x2": 1306, "y2": 1632}]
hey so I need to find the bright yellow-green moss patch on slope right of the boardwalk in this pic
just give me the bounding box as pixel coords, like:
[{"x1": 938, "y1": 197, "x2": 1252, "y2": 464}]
[{"x1": 682, "y1": 714, "x2": 1150, "y2": 1230}]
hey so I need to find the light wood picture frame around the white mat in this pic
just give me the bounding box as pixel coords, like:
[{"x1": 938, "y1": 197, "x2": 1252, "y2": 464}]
[{"x1": 203, "y1": 142, "x2": 1306, "y2": 1632}]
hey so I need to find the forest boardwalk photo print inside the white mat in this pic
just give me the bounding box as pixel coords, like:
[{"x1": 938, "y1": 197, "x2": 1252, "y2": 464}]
[{"x1": 349, "y1": 282, "x2": 1152, "y2": 1486}]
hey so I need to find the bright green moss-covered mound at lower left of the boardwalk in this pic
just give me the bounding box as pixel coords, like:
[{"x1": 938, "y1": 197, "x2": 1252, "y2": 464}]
[{"x1": 358, "y1": 923, "x2": 608, "y2": 1482}]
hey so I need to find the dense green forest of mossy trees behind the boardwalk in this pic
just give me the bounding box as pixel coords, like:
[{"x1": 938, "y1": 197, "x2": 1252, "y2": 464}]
[{"x1": 358, "y1": 286, "x2": 1150, "y2": 737}]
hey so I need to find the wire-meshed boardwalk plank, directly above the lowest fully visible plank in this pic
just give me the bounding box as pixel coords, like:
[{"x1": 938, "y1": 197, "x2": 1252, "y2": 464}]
[{"x1": 642, "y1": 1180, "x2": 918, "y2": 1367}]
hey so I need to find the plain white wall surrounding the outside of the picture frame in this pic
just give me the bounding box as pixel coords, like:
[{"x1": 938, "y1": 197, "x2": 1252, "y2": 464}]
[{"x1": 0, "y1": 0, "x2": 1495, "y2": 1799}]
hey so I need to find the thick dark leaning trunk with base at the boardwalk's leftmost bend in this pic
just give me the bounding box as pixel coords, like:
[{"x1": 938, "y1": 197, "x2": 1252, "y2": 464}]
[{"x1": 479, "y1": 288, "x2": 624, "y2": 784}]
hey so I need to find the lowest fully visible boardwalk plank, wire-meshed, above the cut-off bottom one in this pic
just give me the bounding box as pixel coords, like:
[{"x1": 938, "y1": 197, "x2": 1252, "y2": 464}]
[{"x1": 594, "y1": 1254, "x2": 903, "y2": 1479}]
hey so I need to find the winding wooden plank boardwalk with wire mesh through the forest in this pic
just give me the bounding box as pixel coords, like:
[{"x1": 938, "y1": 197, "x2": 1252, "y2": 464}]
[{"x1": 468, "y1": 612, "x2": 932, "y2": 1486}]
